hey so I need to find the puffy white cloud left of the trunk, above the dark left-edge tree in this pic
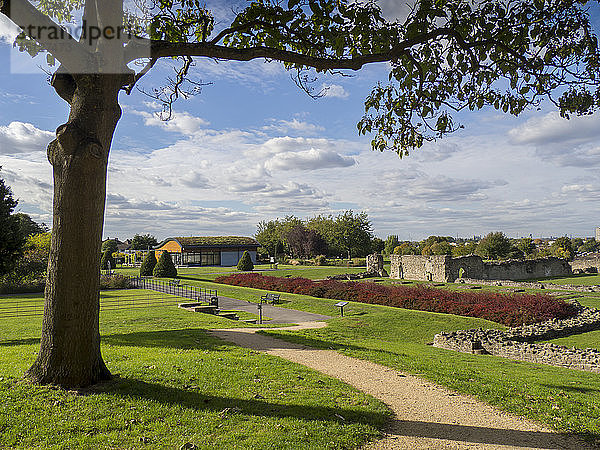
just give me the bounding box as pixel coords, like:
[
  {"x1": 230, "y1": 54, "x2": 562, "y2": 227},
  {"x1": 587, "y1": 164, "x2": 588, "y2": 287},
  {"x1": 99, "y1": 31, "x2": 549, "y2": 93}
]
[{"x1": 0, "y1": 121, "x2": 54, "y2": 155}]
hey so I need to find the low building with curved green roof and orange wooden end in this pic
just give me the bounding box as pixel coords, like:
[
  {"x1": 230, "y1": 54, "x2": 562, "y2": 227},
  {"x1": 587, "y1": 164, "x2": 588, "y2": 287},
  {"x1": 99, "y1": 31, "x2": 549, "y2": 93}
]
[{"x1": 155, "y1": 236, "x2": 260, "y2": 267}]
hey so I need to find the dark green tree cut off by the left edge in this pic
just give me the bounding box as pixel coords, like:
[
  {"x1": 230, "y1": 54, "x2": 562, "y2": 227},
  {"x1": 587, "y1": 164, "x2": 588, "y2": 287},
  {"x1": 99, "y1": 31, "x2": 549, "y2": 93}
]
[{"x1": 0, "y1": 171, "x2": 25, "y2": 275}]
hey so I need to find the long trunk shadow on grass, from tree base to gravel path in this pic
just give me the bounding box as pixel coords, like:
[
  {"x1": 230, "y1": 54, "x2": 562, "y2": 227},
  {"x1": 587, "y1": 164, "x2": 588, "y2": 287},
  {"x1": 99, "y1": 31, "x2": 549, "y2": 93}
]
[{"x1": 92, "y1": 377, "x2": 390, "y2": 428}]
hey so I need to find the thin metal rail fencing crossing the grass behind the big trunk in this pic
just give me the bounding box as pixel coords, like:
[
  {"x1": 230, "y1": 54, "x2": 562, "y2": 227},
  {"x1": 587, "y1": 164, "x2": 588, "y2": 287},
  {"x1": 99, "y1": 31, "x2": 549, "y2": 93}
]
[{"x1": 0, "y1": 277, "x2": 217, "y2": 319}]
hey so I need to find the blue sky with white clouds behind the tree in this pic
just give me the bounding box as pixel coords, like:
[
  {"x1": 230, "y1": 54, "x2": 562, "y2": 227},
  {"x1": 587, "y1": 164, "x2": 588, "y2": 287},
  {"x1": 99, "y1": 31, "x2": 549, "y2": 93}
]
[{"x1": 0, "y1": 1, "x2": 600, "y2": 243}]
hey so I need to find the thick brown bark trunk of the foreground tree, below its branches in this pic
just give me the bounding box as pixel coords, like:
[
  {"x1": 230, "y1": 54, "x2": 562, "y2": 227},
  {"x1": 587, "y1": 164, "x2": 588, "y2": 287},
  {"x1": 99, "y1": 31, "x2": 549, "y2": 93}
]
[{"x1": 26, "y1": 74, "x2": 122, "y2": 387}]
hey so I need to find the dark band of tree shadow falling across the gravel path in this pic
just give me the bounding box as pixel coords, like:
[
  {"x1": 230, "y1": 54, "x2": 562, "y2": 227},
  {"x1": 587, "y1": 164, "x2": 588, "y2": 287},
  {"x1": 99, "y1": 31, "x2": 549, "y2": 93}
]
[{"x1": 388, "y1": 419, "x2": 597, "y2": 450}]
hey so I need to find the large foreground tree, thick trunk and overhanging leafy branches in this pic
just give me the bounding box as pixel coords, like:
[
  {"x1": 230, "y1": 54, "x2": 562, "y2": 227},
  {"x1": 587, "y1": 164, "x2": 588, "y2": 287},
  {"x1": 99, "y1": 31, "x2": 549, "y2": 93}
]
[{"x1": 0, "y1": 0, "x2": 600, "y2": 386}]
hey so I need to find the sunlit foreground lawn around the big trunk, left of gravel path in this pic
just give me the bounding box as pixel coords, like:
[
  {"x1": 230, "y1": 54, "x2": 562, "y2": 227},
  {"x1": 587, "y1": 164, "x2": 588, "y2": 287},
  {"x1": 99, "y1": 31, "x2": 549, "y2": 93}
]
[{"x1": 0, "y1": 291, "x2": 390, "y2": 449}]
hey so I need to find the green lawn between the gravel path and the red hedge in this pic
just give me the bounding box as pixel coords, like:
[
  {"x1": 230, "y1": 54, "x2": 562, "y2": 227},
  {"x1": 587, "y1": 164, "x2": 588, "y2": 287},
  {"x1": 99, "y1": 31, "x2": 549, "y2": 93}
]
[{"x1": 171, "y1": 282, "x2": 600, "y2": 440}]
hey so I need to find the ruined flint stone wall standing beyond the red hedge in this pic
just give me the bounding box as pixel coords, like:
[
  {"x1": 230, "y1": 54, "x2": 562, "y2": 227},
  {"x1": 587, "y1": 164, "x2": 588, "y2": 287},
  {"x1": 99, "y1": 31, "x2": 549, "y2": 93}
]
[{"x1": 390, "y1": 255, "x2": 572, "y2": 283}]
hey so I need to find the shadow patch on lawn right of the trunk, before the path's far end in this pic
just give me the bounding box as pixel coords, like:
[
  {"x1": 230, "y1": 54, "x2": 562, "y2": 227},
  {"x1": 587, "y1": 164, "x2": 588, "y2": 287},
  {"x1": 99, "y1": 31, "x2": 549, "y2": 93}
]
[{"x1": 102, "y1": 328, "x2": 233, "y2": 350}]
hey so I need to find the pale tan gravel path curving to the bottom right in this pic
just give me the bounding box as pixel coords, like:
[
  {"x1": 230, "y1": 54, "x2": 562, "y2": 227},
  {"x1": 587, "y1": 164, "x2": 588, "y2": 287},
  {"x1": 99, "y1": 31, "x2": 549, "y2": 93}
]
[{"x1": 209, "y1": 322, "x2": 593, "y2": 450}]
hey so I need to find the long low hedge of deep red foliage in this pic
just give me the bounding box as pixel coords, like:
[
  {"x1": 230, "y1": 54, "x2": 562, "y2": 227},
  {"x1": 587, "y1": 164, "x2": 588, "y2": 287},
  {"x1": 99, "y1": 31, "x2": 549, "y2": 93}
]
[{"x1": 215, "y1": 274, "x2": 577, "y2": 327}]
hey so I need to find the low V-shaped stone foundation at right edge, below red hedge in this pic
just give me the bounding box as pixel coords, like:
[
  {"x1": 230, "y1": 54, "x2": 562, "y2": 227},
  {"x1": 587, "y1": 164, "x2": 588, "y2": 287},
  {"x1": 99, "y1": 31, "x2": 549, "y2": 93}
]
[{"x1": 433, "y1": 305, "x2": 600, "y2": 373}]
